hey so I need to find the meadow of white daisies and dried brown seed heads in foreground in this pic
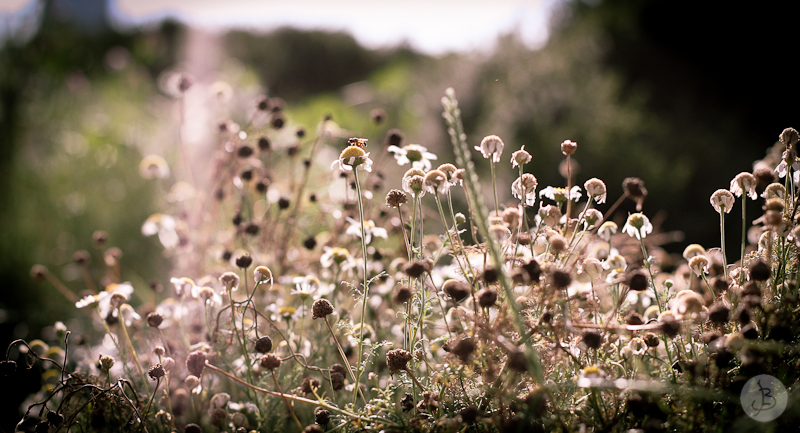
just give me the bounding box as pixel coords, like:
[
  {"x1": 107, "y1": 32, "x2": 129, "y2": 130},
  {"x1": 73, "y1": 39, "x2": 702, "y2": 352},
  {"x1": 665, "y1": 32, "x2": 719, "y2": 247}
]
[{"x1": 6, "y1": 78, "x2": 800, "y2": 433}]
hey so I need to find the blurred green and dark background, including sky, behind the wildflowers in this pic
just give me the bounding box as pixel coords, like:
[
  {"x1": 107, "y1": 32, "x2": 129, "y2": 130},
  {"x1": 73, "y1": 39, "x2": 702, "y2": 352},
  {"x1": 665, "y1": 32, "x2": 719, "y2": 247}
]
[{"x1": 0, "y1": 0, "x2": 800, "y2": 431}]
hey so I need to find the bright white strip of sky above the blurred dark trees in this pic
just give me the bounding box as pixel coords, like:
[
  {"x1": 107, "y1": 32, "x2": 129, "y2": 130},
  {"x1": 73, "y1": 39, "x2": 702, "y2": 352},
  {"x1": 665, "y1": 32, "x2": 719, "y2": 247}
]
[{"x1": 0, "y1": 0, "x2": 564, "y2": 54}]
